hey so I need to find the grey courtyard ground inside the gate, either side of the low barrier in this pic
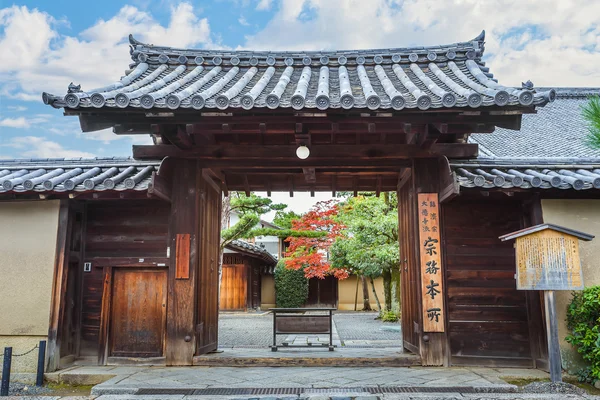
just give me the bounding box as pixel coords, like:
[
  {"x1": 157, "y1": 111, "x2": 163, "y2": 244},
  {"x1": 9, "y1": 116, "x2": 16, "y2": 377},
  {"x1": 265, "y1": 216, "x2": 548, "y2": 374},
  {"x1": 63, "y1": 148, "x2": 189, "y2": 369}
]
[{"x1": 219, "y1": 312, "x2": 402, "y2": 348}]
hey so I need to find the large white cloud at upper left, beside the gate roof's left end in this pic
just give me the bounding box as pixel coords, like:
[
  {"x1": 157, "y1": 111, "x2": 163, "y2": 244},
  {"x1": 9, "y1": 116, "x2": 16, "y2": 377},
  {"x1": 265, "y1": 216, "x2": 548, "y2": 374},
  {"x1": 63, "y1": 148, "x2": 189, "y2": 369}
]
[{"x1": 0, "y1": 2, "x2": 218, "y2": 102}]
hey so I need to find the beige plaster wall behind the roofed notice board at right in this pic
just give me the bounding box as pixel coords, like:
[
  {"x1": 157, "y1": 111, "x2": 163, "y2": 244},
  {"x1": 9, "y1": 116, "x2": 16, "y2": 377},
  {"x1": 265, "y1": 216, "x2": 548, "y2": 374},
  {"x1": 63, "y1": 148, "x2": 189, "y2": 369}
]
[{"x1": 542, "y1": 200, "x2": 600, "y2": 373}]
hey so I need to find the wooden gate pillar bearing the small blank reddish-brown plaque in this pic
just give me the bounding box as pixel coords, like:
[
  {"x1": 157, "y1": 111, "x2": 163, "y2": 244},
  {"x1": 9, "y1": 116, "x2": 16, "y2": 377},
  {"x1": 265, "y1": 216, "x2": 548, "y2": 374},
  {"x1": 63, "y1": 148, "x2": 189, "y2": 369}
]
[{"x1": 166, "y1": 159, "x2": 201, "y2": 365}]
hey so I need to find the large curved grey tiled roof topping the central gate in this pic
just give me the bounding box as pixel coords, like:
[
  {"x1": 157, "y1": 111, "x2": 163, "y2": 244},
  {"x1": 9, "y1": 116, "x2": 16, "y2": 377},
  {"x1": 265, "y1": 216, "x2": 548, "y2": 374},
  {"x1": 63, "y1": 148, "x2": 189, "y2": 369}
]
[{"x1": 43, "y1": 32, "x2": 554, "y2": 110}]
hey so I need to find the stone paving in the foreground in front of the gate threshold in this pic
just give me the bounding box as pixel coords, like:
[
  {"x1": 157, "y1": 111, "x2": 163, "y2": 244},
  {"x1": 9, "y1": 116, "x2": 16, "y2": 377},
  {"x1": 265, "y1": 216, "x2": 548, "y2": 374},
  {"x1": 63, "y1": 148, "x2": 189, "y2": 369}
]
[{"x1": 14, "y1": 367, "x2": 598, "y2": 400}]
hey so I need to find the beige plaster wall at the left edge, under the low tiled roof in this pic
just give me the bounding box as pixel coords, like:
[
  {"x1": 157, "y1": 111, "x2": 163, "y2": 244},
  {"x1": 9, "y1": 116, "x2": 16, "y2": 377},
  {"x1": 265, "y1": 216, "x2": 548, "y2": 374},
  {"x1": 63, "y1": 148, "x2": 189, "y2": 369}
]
[{"x1": 0, "y1": 200, "x2": 59, "y2": 336}]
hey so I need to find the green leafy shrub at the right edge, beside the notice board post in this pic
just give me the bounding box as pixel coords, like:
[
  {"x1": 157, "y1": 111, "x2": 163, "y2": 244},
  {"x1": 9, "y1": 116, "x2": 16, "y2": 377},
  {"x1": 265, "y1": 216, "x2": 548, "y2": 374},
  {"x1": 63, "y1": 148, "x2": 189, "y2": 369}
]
[{"x1": 566, "y1": 286, "x2": 600, "y2": 383}]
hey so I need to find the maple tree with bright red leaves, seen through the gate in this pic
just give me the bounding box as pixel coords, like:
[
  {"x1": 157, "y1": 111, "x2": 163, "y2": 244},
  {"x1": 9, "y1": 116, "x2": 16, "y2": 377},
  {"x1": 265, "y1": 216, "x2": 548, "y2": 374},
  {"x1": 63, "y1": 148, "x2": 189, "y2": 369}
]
[{"x1": 285, "y1": 200, "x2": 349, "y2": 279}]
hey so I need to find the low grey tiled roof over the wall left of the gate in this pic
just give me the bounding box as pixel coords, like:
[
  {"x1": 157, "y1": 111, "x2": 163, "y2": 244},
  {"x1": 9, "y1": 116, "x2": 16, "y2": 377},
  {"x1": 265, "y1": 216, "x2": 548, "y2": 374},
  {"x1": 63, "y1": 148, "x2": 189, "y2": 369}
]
[{"x1": 0, "y1": 158, "x2": 160, "y2": 193}]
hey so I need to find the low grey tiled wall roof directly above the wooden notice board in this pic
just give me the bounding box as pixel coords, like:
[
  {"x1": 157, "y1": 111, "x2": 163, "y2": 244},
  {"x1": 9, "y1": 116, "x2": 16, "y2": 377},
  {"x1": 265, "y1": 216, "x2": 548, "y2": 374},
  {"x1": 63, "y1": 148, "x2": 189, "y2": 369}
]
[{"x1": 450, "y1": 158, "x2": 600, "y2": 190}]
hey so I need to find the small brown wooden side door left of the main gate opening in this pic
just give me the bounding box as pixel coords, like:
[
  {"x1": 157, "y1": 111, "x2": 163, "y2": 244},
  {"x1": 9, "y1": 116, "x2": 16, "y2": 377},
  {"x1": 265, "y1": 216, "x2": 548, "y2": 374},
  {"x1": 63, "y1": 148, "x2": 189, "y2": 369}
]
[{"x1": 109, "y1": 267, "x2": 167, "y2": 357}]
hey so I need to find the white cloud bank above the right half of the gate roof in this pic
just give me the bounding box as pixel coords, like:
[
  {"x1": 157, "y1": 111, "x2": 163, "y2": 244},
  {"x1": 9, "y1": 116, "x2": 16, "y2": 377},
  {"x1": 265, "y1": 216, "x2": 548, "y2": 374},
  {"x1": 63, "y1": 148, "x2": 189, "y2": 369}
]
[{"x1": 244, "y1": 0, "x2": 600, "y2": 86}]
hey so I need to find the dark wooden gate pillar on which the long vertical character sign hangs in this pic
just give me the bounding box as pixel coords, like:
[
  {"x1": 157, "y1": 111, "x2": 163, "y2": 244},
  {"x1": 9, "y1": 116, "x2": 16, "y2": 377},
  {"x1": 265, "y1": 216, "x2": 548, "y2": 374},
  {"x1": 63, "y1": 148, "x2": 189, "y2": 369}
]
[{"x1": 411, "y1": 158, "x2": 448, "y2": 366}]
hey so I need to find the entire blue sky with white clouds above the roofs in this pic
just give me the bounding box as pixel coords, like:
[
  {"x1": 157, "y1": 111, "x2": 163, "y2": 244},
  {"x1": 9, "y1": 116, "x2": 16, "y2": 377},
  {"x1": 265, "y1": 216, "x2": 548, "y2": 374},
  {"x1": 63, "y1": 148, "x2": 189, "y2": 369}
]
[{"x1": 0, "y1": 0, "x2": 600, "y2": 158}]
